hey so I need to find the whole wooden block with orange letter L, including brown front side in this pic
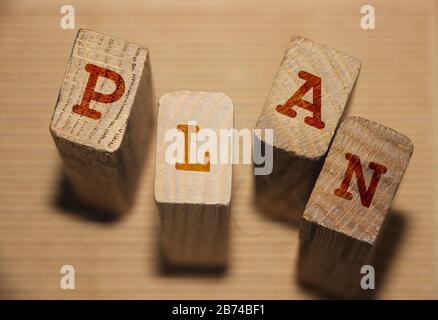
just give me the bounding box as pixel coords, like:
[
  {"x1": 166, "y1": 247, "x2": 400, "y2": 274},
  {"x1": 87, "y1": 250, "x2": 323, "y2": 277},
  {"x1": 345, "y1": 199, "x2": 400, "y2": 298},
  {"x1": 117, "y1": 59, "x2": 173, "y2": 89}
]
[{"x1": 154, "y1": 91, "x2": 234, "y2": 268}]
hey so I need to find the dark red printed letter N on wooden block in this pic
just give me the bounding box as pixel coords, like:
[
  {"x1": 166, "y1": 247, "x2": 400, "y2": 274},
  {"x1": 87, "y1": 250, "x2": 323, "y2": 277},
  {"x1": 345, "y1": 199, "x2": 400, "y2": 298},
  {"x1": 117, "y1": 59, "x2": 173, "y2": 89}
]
[{"x1": 335, "y1": 153, "x2": 388, "y2": 208}]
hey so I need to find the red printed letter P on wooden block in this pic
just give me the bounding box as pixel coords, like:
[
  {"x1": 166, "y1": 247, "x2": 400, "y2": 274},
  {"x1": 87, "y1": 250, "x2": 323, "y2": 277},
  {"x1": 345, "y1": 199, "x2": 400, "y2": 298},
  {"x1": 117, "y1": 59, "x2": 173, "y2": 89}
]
[{"x1": 73, "y1": 64, "x2": 125, "y2": 120}]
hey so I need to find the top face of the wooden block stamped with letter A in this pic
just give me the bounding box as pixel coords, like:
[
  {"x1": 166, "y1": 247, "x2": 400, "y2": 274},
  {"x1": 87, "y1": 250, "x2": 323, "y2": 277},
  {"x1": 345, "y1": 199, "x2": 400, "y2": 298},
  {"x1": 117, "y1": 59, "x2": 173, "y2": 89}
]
[{"x1": 256, "y1": 36, "x2": 360, "y2": 158}]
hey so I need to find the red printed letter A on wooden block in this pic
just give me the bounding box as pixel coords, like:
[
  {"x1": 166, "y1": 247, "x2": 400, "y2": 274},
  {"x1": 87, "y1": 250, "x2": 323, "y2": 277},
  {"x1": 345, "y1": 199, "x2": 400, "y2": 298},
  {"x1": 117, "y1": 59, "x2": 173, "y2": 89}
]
[{"x1": 276, "y1": 71, "x2": 325, "y2": 129}]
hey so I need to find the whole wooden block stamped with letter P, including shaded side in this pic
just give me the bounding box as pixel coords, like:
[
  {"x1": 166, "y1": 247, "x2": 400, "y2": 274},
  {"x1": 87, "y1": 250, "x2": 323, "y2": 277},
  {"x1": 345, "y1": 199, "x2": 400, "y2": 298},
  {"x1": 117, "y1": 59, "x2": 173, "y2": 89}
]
[{"x1": 50, "y1": 30, "x2": 154, "y2": 213}]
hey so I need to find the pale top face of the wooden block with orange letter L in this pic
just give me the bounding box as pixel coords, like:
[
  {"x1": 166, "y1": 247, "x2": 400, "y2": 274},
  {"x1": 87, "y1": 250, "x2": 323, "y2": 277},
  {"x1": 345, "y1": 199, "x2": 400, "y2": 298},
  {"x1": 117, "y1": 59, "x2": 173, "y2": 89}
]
[{"x1": 154, "y1": 91, "x2": 234, "y2": 205}]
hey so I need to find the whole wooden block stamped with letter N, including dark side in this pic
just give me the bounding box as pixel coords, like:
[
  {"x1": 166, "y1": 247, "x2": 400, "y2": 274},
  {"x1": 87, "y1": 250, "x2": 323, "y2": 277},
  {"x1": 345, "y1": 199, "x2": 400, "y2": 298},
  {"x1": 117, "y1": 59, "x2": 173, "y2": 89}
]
[{"x1": 298, "y1": 117, "x2": 413, "y2": 298}]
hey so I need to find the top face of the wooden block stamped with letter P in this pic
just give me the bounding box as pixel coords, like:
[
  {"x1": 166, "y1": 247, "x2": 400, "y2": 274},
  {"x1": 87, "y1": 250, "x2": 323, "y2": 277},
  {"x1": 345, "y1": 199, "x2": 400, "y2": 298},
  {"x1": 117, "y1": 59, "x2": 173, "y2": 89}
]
[{"x1": 50, "y1": 29, "x2": 148, "y2": 152}]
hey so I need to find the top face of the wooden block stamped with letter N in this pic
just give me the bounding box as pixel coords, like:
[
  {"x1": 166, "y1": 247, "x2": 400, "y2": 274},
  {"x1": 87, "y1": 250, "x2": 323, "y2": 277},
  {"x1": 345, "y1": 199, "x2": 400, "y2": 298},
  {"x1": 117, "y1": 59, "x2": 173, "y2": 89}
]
[{"x1": 304, "y1": 117, "x2": 413, "y2": 244}]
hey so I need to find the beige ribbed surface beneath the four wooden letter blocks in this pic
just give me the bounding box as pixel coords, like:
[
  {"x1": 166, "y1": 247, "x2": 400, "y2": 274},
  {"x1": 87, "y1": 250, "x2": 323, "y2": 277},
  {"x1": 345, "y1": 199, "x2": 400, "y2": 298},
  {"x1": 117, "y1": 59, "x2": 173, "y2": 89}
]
[{"x1": 0, "y1": 0, "x2": 438, "y2": 298}]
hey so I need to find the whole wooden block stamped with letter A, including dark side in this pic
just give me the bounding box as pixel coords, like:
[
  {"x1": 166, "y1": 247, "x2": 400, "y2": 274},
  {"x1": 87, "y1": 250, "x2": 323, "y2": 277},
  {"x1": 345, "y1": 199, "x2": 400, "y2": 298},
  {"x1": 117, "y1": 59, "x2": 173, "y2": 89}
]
[{"x1": 255, "y1": 36, "x2": 360, "y2": 222}]
